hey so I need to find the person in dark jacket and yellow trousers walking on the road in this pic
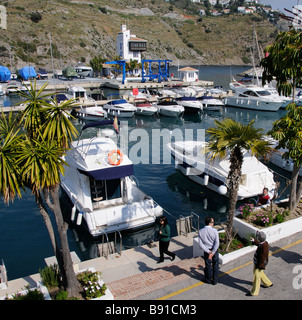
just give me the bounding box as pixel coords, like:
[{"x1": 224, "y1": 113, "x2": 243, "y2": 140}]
[{"x1": 247, "y1": 231, "x2": 273, "y2": 296}]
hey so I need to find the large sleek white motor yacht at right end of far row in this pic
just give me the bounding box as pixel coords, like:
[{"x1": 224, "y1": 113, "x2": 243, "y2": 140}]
[{"x1": 223, "y1": 82, "x2": 284, "y2": 111}]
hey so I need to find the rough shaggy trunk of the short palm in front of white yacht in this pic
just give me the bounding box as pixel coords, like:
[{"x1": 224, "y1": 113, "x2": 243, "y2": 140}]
[{"x1": 225, "y1": 147, "x2": 243, "y2": 248}]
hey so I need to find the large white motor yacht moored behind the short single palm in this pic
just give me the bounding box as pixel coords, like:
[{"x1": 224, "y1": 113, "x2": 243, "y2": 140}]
[{"x1": 167, "y1": 141, "x2": 275, "y2": 200}]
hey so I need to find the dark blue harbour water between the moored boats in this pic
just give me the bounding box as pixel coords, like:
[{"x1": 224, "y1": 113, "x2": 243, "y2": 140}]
[{"x1": 0, "y1": 67, "x2": 289, "y2": 280}]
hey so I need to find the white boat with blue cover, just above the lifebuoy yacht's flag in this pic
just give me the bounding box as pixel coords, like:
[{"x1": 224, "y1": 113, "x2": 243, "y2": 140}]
[{"x1": 103, "y1": 95, "x2": 136, "y2": 118}]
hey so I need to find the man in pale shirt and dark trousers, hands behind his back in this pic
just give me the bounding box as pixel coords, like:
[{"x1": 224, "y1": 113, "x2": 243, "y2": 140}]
[{"x1": 198, "y1": 217, "x2": 219, "y2": 285}]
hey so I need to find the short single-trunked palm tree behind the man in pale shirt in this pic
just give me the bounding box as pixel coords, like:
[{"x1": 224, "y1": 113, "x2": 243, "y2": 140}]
[{"x1": 207, "y1": 118, "x2": 272, "y2": 247}]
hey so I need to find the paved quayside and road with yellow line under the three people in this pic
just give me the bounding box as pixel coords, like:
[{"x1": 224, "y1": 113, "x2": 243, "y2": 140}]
[{"x1": 0, "y1": 232, "x2": 302, "y2": 301}]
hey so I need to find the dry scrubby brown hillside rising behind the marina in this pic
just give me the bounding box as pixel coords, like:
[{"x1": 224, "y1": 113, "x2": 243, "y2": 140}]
[{"x1": 0, "y1": 0, "x2": 277, "y2": 70}]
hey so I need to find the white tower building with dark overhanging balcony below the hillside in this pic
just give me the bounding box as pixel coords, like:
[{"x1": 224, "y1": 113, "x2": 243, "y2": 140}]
[{"x1": 117, "y1": 24, "x2": 148, "y2": 63}]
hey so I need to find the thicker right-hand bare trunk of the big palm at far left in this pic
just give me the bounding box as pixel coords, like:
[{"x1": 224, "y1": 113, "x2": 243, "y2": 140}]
[{"x1": 50, "y1": 185, "x2": 80, "y2": 297}]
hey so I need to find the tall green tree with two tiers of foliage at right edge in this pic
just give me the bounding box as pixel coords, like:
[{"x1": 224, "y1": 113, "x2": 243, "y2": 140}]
[{"x1": 261, "y1": 28, "x2": 302, "y2": 211}]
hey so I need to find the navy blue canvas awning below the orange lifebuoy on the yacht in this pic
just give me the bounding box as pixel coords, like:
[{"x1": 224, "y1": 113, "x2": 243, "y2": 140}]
[{"x1": 78, "y1": 164, "x2": 134, "y2": 180}]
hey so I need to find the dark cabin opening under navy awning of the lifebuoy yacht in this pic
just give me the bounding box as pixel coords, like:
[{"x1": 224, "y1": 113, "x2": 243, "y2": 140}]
[{"x1": 90, "y1": 178, "x2": 122, "y2": 202}]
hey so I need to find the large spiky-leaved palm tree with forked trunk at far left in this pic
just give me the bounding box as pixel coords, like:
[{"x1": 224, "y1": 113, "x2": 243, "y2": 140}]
[{"x1": 0, "y1": 82, "x2": 80, "y2": 296}]
